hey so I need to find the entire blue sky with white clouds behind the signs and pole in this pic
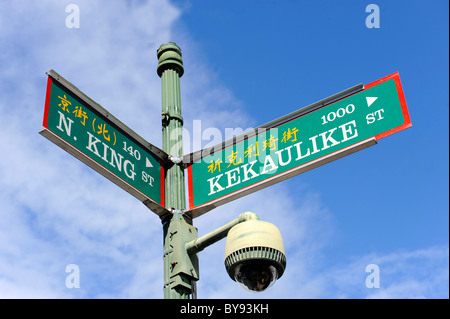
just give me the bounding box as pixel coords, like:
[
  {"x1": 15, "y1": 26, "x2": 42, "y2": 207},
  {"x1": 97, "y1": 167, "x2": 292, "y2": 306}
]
[{"x1": 0, "y1": 0, "x2": 449, "y2": 298}]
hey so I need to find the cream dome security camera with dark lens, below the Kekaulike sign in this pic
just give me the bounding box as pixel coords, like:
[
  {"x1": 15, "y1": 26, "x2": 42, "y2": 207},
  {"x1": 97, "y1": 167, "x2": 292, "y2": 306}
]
[{"x1": 225, "y1": 219, "x2": 286, "y2": 292}]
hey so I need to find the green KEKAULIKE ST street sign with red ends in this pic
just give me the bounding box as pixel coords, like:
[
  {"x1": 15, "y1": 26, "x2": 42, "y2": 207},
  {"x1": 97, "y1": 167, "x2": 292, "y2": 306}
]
[{"x1": 188, "y1": 73, "x2": 411, "y2": 217}]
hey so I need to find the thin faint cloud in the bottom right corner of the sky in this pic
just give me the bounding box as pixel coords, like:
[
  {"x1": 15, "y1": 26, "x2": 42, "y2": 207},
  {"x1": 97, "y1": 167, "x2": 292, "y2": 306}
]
[{"x1": 312, "y1": 246, "x2": 449, "y2": 299}]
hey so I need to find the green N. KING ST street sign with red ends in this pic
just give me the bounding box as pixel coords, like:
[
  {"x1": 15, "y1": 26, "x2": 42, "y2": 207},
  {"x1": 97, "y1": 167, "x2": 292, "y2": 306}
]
[{"x1": 40, "y1": 70, "x2": 167, "y2": 215}]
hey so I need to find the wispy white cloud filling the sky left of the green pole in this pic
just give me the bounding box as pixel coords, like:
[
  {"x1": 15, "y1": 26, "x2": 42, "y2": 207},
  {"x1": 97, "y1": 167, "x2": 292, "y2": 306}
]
[{"x1": 0, "y1": 1, "x2": 179, "y2": 298}]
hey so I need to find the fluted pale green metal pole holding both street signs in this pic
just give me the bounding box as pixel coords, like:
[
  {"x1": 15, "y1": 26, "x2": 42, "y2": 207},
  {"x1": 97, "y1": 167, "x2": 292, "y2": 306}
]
[{"x1": 157, "y1": 42, "x2": 198, "y2": 299}]
